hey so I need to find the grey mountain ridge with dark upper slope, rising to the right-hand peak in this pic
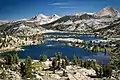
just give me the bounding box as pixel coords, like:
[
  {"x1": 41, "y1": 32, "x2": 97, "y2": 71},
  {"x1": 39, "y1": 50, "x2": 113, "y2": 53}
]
[{"x1": 41, "y1": 7, "x2": 120, "y2": 32}]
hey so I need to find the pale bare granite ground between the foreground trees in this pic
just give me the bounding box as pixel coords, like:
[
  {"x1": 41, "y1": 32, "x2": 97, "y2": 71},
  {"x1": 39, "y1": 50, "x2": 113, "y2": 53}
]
[{"x1": 0, "y1": 60, "x2": 96, "y2": 80}]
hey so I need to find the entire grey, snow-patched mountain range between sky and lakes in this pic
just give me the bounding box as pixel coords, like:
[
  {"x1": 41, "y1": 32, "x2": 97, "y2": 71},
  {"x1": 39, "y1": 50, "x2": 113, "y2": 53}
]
[{"x1": 0, "y1": 7, "x2": 120, "y2": 36}]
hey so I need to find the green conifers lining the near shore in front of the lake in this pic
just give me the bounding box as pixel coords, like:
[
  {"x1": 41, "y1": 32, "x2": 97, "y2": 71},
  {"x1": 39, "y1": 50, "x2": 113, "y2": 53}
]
[{"x1": 5, "y1": 52, "x2": 112, "y2": 78}]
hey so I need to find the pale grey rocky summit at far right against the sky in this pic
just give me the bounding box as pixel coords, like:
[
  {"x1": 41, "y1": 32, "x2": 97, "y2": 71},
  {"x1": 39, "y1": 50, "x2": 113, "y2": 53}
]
[{"x1": 95, "y1": 7, "x2": 119, "y2": 17}]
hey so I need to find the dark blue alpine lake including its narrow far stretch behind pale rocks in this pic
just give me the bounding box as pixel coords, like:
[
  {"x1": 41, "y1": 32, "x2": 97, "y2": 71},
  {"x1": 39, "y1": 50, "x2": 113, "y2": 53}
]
[{"x1": 1, "y1": 32, "x2": 110, "y2": 64}]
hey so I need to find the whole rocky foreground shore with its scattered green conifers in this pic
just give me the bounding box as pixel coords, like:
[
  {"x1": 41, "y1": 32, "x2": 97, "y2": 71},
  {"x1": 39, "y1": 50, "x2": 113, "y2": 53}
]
[{"x1": 0, "y1": 53, "x2": 120, "y2": 80}]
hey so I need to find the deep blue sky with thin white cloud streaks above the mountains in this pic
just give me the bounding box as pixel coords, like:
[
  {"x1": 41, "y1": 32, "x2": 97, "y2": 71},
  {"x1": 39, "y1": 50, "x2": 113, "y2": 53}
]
[{"x1": 0, "y1": 0, "x2": 120, "y2": 20}]
